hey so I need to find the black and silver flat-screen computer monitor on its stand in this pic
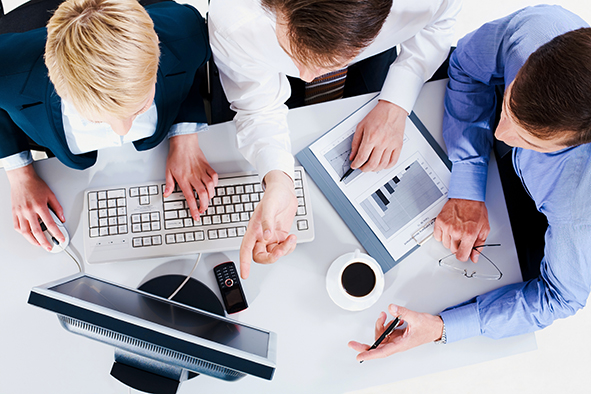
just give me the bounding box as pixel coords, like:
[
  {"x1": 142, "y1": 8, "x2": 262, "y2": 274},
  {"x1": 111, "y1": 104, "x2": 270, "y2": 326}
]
[{"x1": 28, "y1": 274, "x2": 277, "y2": 392}]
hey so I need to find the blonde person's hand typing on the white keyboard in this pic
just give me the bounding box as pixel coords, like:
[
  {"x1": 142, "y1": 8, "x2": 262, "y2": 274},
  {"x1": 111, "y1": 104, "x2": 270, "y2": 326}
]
[{"x1": 164, "y1": 134, "x2": 218, "y2": 220}]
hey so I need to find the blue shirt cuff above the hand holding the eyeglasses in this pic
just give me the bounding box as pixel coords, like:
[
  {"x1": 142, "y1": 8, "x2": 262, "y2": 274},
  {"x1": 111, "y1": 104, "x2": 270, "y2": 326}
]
[{"x1": 448, "y1": 163, "x2": 488, "y2": 201}]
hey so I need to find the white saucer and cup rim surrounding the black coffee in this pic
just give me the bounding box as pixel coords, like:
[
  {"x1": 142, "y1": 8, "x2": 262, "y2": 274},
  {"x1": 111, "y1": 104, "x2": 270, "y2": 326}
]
[{"x1": 326, "y1": 250, "x2": 384, "y2": 311}]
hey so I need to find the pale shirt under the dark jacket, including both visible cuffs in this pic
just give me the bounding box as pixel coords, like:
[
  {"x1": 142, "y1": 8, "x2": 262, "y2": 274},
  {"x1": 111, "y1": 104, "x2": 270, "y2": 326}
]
[{"x1": 2, "y1": 100, "x2": 207, "y2": 171}]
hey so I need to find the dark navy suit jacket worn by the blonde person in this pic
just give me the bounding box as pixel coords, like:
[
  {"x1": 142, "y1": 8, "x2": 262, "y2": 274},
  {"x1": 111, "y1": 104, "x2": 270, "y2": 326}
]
[{"x1": 0, "y1": 1, "x2": 211, "y2": 169}]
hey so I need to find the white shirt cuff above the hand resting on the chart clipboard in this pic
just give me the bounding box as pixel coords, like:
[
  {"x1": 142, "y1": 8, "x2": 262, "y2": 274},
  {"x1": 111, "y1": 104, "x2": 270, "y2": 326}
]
[{"x1": 380, "y1": 65, "x2": 425, "y2": 114}]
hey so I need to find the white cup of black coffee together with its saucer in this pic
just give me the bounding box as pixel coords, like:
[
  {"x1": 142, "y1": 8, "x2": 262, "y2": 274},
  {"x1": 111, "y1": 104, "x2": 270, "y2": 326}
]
[{"x1": 326, "y1": 249, "x2": 384, "y2": 311}]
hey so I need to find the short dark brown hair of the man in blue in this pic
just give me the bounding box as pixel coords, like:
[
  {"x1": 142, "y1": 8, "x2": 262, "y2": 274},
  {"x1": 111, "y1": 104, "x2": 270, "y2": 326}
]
[{"x1": 508, "y1": 28, "x2": 591, "y2": 146}]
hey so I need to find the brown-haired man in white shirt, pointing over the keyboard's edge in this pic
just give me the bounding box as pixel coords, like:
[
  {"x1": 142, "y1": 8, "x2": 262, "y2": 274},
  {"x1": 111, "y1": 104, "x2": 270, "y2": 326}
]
[{"x1": 208, "y1": 0, "x2": 461, "y2": 278}]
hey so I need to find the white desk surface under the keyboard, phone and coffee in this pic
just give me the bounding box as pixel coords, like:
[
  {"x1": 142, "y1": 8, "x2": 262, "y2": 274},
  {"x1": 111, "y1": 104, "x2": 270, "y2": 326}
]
[{"x1": 0, "y1": 81, "x2": 536, "y2": 394}]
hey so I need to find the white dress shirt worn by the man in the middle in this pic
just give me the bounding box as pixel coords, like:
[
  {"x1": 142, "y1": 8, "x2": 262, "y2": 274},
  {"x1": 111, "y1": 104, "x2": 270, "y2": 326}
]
[{"x1": 208, "y1": 0, "x2": 461, "y2": 179}]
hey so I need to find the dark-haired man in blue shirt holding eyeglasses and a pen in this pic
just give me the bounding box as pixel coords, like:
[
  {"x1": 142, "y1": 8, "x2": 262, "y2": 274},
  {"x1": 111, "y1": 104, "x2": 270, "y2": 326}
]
[{"x1": 349, "y1": 6, "x2": 591, "y2": 360}]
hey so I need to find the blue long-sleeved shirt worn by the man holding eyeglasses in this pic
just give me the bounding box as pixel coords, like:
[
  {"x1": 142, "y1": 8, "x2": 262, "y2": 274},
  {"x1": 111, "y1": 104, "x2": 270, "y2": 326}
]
[{"x1": 441, "y1": 6, "x2": 591, "y2": 342}]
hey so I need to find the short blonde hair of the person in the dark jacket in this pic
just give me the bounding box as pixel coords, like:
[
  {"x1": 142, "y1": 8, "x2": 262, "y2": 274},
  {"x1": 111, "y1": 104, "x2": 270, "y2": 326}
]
[{"x1": 45, "y1": 0, "x2": 160, "y2": 119}]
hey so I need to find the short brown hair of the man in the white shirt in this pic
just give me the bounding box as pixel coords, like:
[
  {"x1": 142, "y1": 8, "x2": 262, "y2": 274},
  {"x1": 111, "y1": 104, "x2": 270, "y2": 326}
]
[{"x1": 262, "y1": 0, "x2": 392, "y2": 66}]
